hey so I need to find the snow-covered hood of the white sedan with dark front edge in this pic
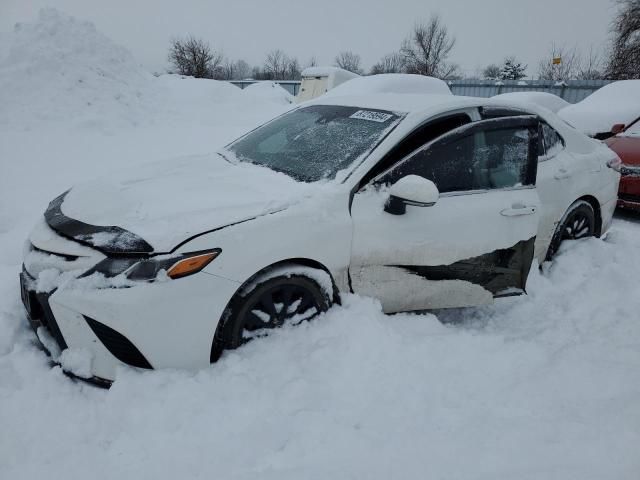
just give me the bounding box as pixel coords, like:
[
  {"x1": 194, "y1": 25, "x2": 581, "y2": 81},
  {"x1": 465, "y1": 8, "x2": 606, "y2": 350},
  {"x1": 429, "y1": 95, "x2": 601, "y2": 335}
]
[{"x1": 45, "y1": 154, "x2": 316, "y2": 253}]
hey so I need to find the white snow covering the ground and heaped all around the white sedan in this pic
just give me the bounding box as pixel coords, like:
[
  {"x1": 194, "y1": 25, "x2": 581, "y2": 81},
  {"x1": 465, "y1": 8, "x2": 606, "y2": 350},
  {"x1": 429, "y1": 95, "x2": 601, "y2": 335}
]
[{"x1": 0, "y1": 10, "x2": 640, "y2": 480}]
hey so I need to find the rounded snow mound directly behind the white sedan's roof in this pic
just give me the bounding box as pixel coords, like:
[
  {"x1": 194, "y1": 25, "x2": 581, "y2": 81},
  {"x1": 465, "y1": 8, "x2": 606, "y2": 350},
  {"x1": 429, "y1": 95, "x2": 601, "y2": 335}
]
[{"x1": 325, "y1": 73, "x2": 451, "y2": 97}]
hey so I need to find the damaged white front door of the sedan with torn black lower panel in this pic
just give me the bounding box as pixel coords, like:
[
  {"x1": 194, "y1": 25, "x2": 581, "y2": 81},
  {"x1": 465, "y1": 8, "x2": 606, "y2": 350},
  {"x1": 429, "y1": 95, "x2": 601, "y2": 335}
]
[{"x1": 349, "y1": 116, "x2": 540, "y2": 312}]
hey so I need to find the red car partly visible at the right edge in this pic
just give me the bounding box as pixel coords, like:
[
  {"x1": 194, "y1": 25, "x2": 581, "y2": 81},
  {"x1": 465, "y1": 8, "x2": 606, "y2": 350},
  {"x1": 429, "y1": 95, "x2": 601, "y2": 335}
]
[{"x1": 605, "y1": 118, "x2": 640, "y2": 211}]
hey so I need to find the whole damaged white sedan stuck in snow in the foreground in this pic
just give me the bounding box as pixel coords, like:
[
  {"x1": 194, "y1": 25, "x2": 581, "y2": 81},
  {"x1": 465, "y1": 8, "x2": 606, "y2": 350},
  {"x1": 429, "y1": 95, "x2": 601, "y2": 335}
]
[{"x1": 21, "y1": 94, "x2": 619, "y2": 382}]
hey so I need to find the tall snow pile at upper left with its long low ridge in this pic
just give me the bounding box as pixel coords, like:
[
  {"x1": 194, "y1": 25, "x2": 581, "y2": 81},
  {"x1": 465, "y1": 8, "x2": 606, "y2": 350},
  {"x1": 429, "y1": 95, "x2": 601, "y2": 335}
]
[{"x1": 0, "y1": 8, "x2": 286, "y2": 130}]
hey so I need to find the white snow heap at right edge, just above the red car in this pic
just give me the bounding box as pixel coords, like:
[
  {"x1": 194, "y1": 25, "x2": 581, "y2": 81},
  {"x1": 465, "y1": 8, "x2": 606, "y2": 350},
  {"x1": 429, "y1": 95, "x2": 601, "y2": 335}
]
[{"x1": 558, "y1": 80, "x2": 640, "y2": 136}]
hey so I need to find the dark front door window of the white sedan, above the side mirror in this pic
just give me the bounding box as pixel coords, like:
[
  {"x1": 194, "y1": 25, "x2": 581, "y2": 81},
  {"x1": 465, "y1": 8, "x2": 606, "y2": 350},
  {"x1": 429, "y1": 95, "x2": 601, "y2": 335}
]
[{"x1": 383, "y1": 127, "x2": 533, "y2": 193}]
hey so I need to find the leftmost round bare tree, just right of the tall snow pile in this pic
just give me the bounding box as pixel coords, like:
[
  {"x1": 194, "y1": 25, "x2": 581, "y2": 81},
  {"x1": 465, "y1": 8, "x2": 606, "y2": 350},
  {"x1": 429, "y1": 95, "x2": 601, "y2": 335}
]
[{"x1": 169, "y1": 36, "x2": 224, "y2": 78}]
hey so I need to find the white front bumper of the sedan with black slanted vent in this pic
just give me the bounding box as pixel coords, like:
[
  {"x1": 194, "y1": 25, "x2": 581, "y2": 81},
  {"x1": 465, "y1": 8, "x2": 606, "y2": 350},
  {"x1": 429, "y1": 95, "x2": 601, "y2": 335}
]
[{"x1": 20, "y1": 264, "x2": 239, "y2": 385}]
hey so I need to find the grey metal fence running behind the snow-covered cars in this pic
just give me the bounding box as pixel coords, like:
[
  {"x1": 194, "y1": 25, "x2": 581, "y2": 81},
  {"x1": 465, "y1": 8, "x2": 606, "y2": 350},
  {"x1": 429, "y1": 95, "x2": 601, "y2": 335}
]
[{"x1": 231, "y1": 80, "x2": 611, "y2": 103}]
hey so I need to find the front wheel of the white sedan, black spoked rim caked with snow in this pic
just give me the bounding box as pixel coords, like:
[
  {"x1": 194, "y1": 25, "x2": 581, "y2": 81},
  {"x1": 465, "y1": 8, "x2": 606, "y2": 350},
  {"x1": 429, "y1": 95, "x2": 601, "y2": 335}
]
[{"x1": 211, "y1": 273, "x2": 333, "y2": 363}]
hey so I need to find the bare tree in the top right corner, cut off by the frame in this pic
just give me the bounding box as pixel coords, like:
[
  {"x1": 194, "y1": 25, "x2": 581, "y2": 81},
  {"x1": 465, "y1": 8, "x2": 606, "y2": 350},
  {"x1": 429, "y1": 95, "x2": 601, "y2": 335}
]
[{"x1": 606, "y1": 0, "x2": 640, "y2": 80}]
